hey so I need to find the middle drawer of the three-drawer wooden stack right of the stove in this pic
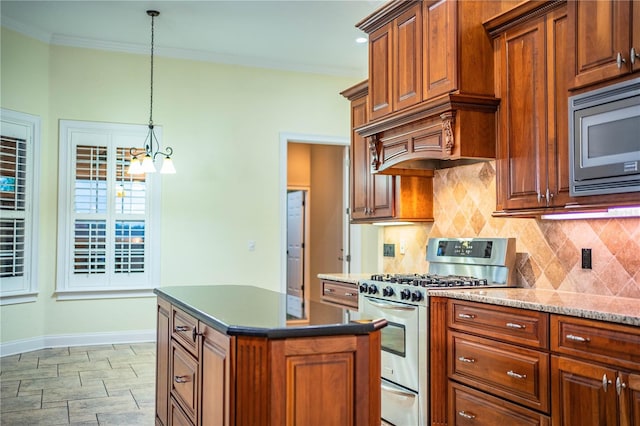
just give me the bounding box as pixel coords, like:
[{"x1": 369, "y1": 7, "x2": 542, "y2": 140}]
[{"x1": 449, "y1": 331, "x2": 549, "y2": 412}]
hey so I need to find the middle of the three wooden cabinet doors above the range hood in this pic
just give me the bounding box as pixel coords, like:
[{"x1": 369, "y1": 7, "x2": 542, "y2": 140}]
[{"x1": 392, "y1": 3, "x2": 422, "y2": 111}]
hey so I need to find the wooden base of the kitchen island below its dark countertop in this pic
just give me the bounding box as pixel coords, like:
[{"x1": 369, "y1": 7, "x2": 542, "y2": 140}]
[{"x1": 155, "y1": 298, "x2": 380, "y2": 426}]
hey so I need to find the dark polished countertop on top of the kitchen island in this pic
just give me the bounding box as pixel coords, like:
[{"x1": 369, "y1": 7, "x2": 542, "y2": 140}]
[{"x1": 154, "y1": 285, "x2": 387, "y2": 338}]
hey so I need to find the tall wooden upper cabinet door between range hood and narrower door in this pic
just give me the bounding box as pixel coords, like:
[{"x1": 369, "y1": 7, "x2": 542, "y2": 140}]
[{"x1": 496, "y1": 17, "x2": 547, "y2": 209}]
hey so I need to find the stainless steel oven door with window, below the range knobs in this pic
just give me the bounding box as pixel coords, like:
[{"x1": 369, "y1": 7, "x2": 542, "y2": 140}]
[{"x1": 360, "y1": 296, "x2": 419, "y2": 391}]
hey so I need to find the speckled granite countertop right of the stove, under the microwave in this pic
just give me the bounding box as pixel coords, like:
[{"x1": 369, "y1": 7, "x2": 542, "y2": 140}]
[{"x1": 429, "y1": 288, "x2": 640, "y2": 327}]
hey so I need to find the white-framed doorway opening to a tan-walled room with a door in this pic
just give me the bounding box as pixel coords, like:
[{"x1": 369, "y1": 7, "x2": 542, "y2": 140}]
[{"x1": 280, "y1": 134, "x2": 349, "y2": 321}]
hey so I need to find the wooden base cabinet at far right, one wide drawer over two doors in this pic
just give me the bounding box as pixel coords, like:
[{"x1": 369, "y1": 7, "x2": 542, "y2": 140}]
[{"x1": 551, "y1": 315, "x2": 640, "y2": 426}]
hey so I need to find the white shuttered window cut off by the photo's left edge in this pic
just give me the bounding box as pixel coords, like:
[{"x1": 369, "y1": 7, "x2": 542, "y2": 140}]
[{"x1": 0, "y1": 109, "x2": 40, "y2": 305}]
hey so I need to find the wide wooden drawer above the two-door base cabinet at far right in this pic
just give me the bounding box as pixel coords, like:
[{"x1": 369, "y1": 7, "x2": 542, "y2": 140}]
[{"x1": 551, "y1": 315, "x2": 640, "y2": 371}]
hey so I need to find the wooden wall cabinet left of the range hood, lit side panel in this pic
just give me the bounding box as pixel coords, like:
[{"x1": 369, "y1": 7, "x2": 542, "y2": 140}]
[{"x1": 341, "y1": 81, "x2": 433, "y2": 223}]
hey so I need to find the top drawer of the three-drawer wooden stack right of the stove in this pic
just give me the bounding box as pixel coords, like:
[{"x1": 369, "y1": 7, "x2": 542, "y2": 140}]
[{"x1": 448, "y1": 300, "x2": 549, "y2": 348}]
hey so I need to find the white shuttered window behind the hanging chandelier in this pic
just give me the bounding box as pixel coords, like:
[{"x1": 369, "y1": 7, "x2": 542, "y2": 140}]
[{"x1": 57, "y1": 120, "x2": 162, "y2": 299}]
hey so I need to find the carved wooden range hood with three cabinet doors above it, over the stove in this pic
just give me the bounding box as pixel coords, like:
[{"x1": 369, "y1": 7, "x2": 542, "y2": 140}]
[{"x1": 355, "y1": 0, "x2": 502, "y2": 175}]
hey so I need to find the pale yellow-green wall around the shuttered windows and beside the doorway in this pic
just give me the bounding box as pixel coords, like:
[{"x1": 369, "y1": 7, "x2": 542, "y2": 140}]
[{"x1": 0, "y1": 28, "x2": 362, "y2": 343}]
